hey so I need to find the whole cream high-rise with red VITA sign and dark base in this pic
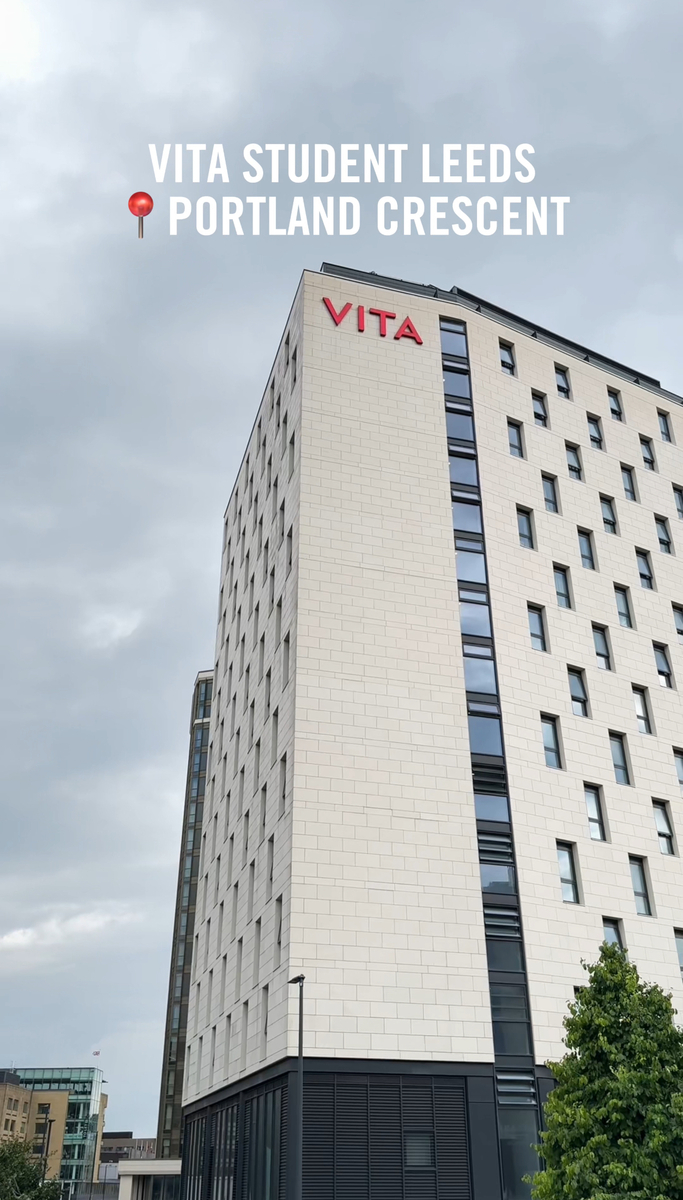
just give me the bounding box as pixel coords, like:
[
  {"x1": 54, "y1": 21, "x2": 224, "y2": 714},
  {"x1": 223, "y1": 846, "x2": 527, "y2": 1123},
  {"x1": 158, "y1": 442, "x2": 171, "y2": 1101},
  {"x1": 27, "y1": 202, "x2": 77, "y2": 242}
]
[{"x1": 184, "y1": 265, "x2": 683, "y2": 1200}]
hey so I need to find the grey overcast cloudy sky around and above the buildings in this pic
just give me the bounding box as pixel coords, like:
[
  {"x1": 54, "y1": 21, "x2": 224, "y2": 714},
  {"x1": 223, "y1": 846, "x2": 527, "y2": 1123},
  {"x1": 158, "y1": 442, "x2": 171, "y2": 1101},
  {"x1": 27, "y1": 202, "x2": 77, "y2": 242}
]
[{"x1": 0, "y1": 0, "x2": 683, "y2": 1136}]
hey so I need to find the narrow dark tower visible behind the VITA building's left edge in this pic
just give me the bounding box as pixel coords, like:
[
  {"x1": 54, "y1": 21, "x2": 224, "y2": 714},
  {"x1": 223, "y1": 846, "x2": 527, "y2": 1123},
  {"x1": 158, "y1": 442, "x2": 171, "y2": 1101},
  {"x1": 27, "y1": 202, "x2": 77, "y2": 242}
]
[{"x1": 152, "y1": 671, "x2": 214, "y2": 1159}]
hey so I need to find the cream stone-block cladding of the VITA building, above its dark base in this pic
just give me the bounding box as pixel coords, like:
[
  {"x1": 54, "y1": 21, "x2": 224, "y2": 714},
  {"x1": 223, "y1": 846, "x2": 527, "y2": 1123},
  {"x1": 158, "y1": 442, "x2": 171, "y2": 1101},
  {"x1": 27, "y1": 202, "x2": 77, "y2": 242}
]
[{"x1": 184, "y1": 271, "x2": 683, "y2": 1200}]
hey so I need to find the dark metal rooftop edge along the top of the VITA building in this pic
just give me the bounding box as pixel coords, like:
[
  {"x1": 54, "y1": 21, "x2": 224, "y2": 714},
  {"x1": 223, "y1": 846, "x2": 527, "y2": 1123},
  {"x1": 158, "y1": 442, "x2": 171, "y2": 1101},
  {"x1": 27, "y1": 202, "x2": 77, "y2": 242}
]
[{"x1": 319, "y1": 263, "x2": 683, "y2": 404}]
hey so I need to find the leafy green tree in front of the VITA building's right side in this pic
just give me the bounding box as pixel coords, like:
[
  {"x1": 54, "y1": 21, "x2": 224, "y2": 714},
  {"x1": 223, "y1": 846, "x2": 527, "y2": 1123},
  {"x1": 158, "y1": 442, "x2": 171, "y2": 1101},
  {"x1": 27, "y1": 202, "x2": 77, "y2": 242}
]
[{"x1": 532, "y1": 943, "x2": 683, "y2": 1200}]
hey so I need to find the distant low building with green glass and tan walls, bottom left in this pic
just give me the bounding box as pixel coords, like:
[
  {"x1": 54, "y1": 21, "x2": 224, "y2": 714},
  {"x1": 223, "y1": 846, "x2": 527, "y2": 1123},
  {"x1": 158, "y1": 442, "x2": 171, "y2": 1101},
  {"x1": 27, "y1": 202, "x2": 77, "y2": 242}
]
[{"x1": 13, "y1": 1067, "x2": 107, "y2": 1198}]
